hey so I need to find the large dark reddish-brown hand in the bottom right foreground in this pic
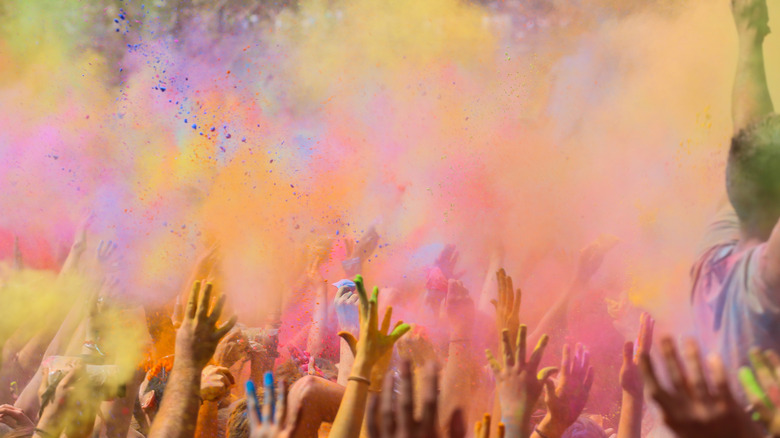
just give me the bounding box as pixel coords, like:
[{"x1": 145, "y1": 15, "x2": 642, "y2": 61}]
[{"x1": 640, "y1": 337, "x2": 761, "y2": 438}]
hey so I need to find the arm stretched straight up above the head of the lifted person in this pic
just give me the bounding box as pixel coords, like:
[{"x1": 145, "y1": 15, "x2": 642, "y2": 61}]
[{"x1": 731, "y1": 0, "x2": 774, "y2": 133}]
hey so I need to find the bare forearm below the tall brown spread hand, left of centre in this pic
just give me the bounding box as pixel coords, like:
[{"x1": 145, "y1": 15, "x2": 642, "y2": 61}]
[{"x1": 149, "y1": 361, "x2": 203, "y2": 438}]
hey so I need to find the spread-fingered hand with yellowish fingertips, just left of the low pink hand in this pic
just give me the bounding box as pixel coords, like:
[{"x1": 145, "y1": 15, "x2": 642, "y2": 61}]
[{"x1": 486, "y1": 325, "x2": 558, "y2": 436}]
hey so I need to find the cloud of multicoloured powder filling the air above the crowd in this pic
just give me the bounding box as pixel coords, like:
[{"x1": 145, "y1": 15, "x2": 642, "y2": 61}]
[{"x1": 0, "y1": 0, "x2": 780, "y2": 396}]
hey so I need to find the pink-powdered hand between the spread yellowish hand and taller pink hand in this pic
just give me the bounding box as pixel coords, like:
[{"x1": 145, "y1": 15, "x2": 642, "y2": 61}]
[{"x1": 538, "y1": 344, "x2": 593, "y2": 438}]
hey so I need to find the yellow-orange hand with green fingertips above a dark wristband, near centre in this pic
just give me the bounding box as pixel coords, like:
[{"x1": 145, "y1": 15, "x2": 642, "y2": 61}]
[{"x1": 338, "y1": 275, "x2": 411, "y2": 384}]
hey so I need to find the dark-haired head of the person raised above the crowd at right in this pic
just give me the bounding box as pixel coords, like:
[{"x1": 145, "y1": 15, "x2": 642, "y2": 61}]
[{"x1": 726, "y1": 114, "x2": 780, "y2": 240}]
